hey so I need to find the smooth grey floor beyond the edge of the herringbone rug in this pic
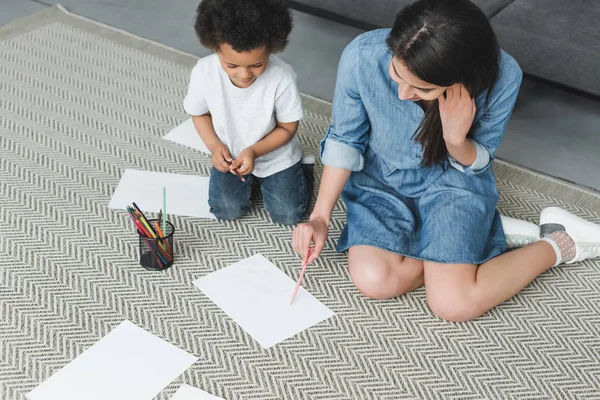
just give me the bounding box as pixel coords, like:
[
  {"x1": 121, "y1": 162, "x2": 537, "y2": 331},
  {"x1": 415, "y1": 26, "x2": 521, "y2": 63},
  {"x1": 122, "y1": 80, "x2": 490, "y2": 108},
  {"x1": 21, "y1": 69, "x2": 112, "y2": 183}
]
[{"x1": 0, "y1": 0, "x2": 600, "y2": 190}]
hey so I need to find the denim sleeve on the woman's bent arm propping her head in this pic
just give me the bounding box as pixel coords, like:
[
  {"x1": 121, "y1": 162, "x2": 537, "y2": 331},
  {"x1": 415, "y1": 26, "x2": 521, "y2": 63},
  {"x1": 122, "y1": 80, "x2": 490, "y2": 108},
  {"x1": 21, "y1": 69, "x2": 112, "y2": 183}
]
[{"x1": 449, "y1": 65, "x2": 523, "y2": 175}]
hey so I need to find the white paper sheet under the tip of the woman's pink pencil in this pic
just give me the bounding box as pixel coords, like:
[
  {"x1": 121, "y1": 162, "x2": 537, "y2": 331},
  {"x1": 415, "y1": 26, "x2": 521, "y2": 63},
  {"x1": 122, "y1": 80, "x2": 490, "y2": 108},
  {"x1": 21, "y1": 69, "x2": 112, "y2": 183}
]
[{"x1": 194, "y1": 254, "x2": 334, "y2": 348}]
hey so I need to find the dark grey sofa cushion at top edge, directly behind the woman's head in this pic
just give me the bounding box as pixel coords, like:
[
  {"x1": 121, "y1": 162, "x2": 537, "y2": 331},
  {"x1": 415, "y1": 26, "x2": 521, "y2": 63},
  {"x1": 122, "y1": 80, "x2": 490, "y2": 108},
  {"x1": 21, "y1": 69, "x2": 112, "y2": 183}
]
[{"x1": 290, "y1": 0, "x2": 514, "y2": 27}]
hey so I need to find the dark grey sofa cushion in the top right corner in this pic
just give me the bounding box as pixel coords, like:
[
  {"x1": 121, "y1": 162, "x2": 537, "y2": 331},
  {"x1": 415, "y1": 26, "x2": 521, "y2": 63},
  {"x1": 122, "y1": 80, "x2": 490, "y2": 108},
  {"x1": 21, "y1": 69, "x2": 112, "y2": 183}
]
[{"x1": 491, "y1": 0, "x2": 600, "y2": 95}]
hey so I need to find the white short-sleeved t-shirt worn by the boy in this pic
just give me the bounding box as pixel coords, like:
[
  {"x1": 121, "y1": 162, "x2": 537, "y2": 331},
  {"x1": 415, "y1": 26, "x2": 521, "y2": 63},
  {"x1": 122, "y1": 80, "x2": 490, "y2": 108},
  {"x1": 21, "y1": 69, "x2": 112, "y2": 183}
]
[{"x1": 183, "y1": 54, "x2": 304, "y2": 178}]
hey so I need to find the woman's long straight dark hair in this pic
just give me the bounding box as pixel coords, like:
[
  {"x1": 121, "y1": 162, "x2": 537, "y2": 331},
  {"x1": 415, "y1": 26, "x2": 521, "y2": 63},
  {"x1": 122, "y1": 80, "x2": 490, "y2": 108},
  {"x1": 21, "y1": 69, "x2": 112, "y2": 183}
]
[{"x1": 387, "y1": 0, "x2": 500, "y2": 167}]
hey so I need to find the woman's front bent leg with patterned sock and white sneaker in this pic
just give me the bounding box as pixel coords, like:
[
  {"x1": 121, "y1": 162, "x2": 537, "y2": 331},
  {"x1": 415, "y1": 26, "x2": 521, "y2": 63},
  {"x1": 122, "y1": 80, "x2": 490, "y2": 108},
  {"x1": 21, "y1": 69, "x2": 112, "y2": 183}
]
[{"x1": 424, "y1": 207, "x2": 600, "y2": 321}]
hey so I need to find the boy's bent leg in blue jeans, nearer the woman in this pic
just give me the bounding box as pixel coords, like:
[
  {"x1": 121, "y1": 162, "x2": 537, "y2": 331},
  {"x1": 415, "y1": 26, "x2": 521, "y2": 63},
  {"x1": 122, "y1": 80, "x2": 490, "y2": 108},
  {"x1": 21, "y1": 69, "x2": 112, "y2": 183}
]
[{"x1": 259, "y1": 162, "x2": 312, "y2": 225}]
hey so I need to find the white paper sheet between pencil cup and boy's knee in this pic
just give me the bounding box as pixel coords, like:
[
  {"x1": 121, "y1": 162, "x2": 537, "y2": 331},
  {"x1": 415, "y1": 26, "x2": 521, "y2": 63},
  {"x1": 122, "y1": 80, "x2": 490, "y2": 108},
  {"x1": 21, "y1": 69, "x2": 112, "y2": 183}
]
[{"x1": 108, "y1": 169, "x2": 215, "y2": 219}]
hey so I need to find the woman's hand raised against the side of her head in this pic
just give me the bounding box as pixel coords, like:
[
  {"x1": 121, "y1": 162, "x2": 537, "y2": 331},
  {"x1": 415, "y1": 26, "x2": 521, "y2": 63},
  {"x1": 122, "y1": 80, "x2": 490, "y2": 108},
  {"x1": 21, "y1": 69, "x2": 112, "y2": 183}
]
[{"x1": 438, "y1": 83, "x2": 477, "y2": 146}]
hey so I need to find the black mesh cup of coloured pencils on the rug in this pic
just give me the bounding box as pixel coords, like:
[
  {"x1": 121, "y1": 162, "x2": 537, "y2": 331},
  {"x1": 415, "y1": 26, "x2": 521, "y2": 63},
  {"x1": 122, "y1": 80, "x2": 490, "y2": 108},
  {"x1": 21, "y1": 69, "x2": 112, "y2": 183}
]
[{"x1": 138, "y1": 219, "x2": 175, "y2": 271}]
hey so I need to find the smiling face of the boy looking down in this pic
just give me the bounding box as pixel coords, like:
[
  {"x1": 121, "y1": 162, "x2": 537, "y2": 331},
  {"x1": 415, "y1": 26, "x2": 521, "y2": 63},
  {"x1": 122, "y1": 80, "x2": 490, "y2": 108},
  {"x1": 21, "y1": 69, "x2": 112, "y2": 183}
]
[{"x1": 217, "y1": 43, "x2": 271, "y2": 88}]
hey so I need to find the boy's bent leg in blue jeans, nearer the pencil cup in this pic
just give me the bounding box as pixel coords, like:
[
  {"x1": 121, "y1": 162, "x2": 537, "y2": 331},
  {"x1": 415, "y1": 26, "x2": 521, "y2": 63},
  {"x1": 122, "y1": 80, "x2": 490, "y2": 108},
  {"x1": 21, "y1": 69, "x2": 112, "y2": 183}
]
[{"x1": 208, "y1": 167, "x2": 253, "y2": 220}]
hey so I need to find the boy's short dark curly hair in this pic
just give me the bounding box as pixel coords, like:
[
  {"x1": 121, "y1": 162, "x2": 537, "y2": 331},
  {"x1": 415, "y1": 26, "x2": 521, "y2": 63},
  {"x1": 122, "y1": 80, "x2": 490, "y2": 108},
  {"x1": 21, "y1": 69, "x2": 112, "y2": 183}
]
[{"x1": 194, "y1": 0, "x2": 292, "y2": 52}]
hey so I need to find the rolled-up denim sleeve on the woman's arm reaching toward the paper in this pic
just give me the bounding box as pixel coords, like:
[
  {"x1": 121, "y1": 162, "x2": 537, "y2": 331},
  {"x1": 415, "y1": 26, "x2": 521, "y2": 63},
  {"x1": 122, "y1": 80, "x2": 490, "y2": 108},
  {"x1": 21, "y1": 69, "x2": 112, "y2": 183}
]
[{"x1": 321, "y1": 39, "x2": 371, "y2": 171}]
